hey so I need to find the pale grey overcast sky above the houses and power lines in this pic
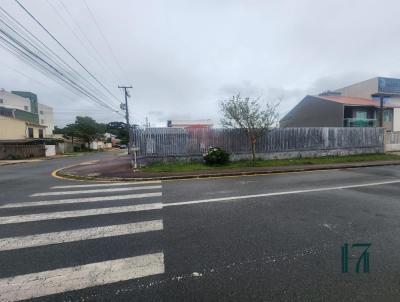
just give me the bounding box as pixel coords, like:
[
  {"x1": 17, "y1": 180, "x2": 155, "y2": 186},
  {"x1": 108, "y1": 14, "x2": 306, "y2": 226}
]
[{"x1": 0, "y1": 0, "x2": 400, "y2": 126}]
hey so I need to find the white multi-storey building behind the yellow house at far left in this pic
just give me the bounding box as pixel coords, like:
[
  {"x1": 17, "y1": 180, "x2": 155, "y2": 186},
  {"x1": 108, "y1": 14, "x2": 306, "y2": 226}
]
[{"x1": 0, "y1": 89, "x2": 54, "y2": 137}]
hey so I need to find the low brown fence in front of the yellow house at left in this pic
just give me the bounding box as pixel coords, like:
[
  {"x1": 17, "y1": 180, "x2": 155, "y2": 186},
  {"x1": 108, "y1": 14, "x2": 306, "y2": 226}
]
[{"x1": 0, "y1": 144, "x2": 46, "y2": 159}]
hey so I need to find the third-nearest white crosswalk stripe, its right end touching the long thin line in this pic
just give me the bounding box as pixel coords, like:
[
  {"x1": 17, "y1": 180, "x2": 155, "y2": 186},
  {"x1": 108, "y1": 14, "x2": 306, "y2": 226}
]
[{"x1": 0, "y1": 203, "x2": 162, "y2": 224}]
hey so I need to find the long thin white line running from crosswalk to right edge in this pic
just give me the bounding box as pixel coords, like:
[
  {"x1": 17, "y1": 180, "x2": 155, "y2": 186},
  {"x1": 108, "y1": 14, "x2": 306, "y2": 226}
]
[{"x1": 163, "y1": 180, "x2": 400, "y2": 207}]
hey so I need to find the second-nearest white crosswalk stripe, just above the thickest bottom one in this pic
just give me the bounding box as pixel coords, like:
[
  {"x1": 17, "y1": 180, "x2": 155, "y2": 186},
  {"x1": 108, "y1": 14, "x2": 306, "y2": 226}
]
[{"x1": 0, "y1": 220, "x2": 163, "y2": 251}]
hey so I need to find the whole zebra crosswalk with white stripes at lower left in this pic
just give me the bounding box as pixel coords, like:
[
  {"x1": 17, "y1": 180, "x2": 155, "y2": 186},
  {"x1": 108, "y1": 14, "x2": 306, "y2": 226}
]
[{"x1": 0, "y1": 181, "x2": 165, "y2": 302}]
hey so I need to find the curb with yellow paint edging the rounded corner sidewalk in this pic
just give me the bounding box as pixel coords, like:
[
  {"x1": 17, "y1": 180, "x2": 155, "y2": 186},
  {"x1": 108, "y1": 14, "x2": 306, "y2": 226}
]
[{"x1": 52, "y1": 161, "x2": 400, "y2": 182}]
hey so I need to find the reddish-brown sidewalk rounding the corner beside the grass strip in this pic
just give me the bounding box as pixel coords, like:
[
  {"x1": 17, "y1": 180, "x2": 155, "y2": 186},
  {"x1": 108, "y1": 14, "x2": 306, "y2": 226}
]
[{"x1": 55, "y1": 156, "x2": 400, "y2": 181}]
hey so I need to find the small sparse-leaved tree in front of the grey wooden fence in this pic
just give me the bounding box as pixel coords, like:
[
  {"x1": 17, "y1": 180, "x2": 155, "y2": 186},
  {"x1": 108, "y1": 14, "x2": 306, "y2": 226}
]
[{"x1": 220, "y1": 94, "x2": 279, "y2": 160}]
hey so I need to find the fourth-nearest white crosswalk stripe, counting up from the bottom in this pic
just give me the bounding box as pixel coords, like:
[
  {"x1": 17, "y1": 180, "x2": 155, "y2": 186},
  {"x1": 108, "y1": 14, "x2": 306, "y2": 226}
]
[{"x1": 0, "y1": 192, "x2": 162, "y2": 209}]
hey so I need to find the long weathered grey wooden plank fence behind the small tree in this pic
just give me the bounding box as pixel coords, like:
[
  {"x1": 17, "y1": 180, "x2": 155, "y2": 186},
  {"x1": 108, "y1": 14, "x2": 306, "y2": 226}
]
[{"x1": 132, "y1": 128, "x2": 384, "y2": 157}]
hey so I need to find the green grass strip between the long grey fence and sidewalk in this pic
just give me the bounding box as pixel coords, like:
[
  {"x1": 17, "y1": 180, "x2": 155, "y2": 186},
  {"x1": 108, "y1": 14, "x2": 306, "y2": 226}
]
[{"x1": 143, "y1": 154, "x2": 400, "y2": 172}]
